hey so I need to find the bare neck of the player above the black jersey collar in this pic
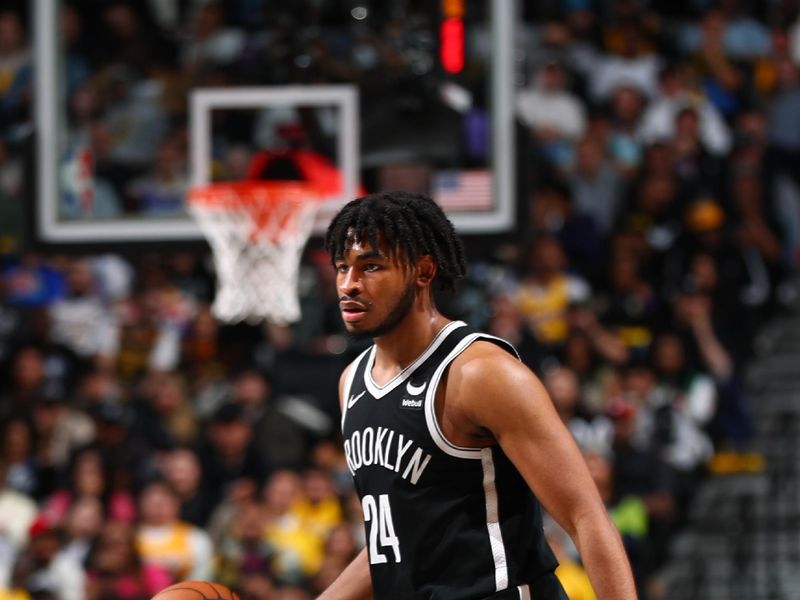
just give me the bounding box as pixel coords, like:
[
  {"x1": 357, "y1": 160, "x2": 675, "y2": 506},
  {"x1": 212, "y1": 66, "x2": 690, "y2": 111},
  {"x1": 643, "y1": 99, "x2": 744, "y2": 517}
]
[{"x1": 373, "y1": 306, "x2": 450, "y2": 381}]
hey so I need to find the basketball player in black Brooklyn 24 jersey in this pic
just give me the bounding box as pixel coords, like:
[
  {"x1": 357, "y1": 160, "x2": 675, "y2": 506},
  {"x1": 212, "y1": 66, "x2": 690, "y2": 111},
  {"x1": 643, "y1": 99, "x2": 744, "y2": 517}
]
[{"x1": 320, "y1": 192, "x2": 636, "y2": 600}]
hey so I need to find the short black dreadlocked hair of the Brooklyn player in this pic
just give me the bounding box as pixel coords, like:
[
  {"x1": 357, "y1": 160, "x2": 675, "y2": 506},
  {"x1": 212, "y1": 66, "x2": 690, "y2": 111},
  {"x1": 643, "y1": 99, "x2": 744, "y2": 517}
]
[{"x1": 325, "y1": 191, "x2": 467, "y2": 290}]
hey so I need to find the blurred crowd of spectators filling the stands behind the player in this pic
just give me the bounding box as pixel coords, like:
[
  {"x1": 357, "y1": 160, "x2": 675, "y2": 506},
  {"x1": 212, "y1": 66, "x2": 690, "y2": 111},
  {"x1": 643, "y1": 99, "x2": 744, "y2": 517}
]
[{"x1": 0, "y1": 0, "x2": 800, "y2": 600}]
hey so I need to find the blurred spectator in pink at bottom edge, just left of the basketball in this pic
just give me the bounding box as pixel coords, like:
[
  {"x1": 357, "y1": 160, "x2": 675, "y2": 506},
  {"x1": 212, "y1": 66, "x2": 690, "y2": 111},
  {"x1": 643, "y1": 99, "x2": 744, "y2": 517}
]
[{"x1": 86, "y1": 520, "x2": 173, "y2": 600}]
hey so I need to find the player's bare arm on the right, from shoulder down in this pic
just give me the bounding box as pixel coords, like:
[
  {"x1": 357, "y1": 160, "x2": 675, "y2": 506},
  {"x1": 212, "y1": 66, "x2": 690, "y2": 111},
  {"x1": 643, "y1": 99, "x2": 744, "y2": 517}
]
[{"x1": 445, "y1": 342, "x2": 636, "y2": 600}]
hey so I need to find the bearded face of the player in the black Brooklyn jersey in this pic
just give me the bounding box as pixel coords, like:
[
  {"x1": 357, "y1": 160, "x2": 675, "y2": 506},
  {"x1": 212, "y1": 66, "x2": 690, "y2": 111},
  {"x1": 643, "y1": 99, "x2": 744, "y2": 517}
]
[{"x1": 336, "y1": 236, "x2": 416, "y2": 337}]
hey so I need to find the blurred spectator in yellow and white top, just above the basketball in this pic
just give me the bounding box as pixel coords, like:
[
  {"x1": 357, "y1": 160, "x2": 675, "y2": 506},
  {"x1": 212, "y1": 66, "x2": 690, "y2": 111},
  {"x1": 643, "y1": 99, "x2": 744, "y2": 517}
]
[{"x1": 136, "y1": 480, "x2": 213, "y2": 583}]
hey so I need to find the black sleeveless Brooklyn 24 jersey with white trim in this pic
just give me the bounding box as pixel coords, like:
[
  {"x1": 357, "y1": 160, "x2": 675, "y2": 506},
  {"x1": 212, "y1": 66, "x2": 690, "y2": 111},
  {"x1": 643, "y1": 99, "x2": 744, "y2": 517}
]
[{"x1": 342, "y1": 321, "x2": 566, "y2": 600}]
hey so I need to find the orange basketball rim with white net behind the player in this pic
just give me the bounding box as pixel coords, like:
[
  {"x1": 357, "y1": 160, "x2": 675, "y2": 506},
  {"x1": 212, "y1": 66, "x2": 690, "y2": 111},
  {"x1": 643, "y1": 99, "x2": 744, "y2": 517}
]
[{"x1": 188, "y1": 181, "x2": 320, "y2": 325}]
